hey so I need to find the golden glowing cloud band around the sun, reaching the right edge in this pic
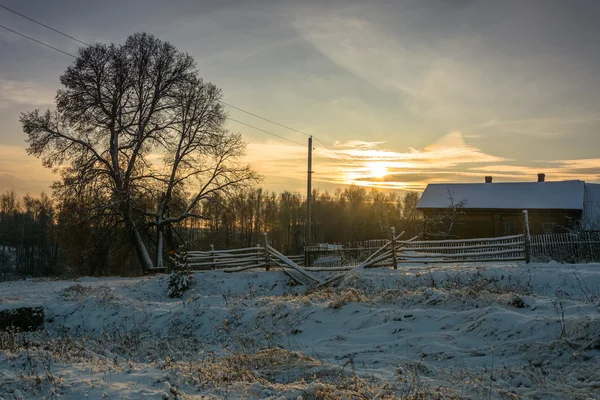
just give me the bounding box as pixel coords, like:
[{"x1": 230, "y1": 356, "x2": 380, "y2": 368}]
[{"x1": 247, "y1": 132, "x2": 600, "y2": 192}]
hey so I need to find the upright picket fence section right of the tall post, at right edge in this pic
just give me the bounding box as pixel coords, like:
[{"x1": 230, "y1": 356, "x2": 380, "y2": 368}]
[{"x1": 531, "y1": 232, "x2": 600, "y2": 262}]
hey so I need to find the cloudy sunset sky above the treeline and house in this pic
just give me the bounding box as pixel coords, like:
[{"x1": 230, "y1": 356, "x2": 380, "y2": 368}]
[{"x1": 0, "y1": 0, "x2": 600, "y2": 194}]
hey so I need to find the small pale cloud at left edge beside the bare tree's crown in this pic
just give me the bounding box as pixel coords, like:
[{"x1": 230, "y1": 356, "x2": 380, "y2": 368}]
[{"x1": 0, "y1": 78, "x2": 56, "y2": 108}]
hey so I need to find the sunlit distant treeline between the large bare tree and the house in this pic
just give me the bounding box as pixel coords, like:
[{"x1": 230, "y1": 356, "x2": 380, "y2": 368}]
[{"x1": 190, "y1": 186, "x2": 422, "y2": 254}]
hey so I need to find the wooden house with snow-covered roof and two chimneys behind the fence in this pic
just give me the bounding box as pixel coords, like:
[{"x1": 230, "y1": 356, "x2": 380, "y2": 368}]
[{"x1": 417, "y1": 174, "x2": 586, "y2": 239}]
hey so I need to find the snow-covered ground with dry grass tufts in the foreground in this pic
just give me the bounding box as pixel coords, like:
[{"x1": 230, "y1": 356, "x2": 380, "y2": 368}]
[{"x1": 0, "y1": 263, "x2": 600, "y2": 400}]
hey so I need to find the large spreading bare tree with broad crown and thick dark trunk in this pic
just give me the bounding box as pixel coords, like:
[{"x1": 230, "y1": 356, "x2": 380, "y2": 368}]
[{"x1": 21, "y1": 33, "x2": 256, "y2": 270}]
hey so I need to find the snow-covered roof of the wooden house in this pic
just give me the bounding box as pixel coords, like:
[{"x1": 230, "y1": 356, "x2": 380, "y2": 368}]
[{"x1": 417, "y1": 180, "x2": 584, "y2": 210}]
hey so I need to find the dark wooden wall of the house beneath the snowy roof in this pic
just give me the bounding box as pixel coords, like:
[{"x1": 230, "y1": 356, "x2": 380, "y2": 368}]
[{"x1": 421, "y1": 209, "x2": 581, "y2": 239}]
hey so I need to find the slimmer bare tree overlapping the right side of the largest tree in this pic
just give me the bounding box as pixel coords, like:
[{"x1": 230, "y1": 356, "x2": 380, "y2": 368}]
[{"x1": 150, "y1": 78, "x2": 258, "y2": 268}]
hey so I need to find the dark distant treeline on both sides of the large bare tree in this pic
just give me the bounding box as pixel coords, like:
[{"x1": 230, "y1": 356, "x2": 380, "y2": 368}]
[{"x1": 0, "y1": 186, "x2": 422, "y2": 276}]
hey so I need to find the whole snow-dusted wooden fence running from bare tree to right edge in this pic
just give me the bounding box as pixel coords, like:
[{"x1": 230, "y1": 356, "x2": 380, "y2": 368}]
[{"x1": 173, "y1": 230, "x2": 600, "y2": 276}]
